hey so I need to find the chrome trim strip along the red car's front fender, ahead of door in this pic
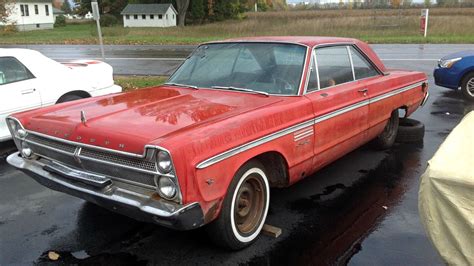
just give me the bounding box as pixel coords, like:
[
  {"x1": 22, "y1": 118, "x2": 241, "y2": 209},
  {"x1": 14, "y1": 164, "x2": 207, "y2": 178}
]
[{"x1": 196, "y1": 119, "x2": 314, "y2": 169}]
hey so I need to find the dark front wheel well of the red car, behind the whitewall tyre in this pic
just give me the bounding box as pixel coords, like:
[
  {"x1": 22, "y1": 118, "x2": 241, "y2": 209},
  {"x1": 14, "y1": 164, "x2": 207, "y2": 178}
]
[{"x1": 252, "y1": 151, "x2": 289, "y2": 187}]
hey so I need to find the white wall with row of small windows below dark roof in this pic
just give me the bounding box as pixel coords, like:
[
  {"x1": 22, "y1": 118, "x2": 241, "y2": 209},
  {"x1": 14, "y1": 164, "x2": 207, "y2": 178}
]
[{"x1": 123, "y1": 8, "x2": 177, "y2": 27}]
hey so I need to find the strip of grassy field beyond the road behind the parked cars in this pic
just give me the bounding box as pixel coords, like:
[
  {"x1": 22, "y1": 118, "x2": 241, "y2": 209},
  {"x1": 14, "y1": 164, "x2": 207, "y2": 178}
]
[{"x1": 0, "y1": 8, "x2": 474, "y2": 44}]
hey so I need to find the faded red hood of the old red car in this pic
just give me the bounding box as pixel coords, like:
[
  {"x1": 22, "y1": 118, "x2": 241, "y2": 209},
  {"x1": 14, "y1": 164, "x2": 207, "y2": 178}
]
[{"x1": 25, "y1": 87, "x2": 281, "y2": 154}]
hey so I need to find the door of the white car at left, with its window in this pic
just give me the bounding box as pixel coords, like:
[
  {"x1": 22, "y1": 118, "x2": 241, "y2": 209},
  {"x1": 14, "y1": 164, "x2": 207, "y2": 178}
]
[{"x1": 0, "y1": 57, "x2": 41, "y2": 140}]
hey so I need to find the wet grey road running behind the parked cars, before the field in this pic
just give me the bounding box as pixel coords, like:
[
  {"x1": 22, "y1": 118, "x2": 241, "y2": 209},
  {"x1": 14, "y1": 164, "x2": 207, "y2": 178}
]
[{"x1": 0, "y1": 44, "x2": 474, "y2": 76}]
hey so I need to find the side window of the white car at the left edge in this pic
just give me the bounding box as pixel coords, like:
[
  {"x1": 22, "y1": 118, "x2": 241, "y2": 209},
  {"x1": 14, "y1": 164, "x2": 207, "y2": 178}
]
[{"x1": 0, "y1": 57, "x2": 34, "y2": 85}]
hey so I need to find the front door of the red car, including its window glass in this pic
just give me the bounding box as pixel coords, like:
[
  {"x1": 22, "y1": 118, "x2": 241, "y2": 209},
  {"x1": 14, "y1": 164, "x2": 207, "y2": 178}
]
[{"x1": 306, "y1": 45, "x2": 369, "y2": 170}]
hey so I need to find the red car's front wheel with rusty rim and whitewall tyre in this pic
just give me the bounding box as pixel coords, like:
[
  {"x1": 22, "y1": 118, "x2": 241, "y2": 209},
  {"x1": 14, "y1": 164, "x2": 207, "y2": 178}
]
[{"x1": 207, "y1": 161, "x2": 270, "y2": 250}]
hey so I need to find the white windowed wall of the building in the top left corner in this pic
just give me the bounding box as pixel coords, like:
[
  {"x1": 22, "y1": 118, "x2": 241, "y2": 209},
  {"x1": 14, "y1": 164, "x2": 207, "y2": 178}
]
[{"x1": 0, "y1": 1, "x2": 54, "y2": 30}]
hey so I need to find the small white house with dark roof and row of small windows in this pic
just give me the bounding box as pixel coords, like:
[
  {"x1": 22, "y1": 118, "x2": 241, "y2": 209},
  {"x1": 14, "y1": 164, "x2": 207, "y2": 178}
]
[{"x1": 120, "y1": 4, "x2": 178, "y2": 27}]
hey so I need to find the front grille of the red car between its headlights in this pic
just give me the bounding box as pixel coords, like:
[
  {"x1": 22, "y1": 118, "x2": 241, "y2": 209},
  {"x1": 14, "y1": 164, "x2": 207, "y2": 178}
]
[{"x1": 26, "y1": 134, "x2": 156, "y2": 187}]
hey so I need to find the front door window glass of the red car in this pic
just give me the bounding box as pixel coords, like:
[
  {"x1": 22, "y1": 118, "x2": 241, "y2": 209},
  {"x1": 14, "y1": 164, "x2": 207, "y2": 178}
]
[{"x1": 316, "y1": 46, "x2": 354, "y2": 89}]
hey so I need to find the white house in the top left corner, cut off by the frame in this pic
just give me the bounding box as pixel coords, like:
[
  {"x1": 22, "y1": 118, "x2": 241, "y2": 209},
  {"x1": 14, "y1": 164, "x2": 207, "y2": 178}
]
[{"x1": 0, "y1": 0, "x2": 54, "y2": 31}]
